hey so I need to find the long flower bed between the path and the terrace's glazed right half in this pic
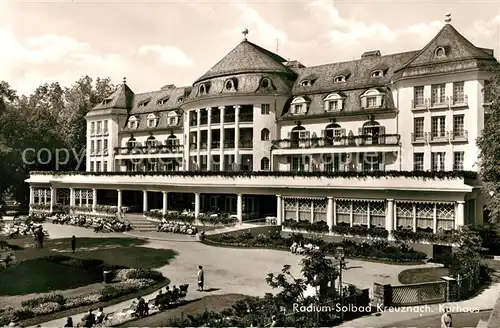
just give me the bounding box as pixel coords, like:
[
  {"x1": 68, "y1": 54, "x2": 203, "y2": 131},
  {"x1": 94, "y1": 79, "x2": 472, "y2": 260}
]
[{"x1": 203, "y1": 232, "x2": 427, "y2": 263}]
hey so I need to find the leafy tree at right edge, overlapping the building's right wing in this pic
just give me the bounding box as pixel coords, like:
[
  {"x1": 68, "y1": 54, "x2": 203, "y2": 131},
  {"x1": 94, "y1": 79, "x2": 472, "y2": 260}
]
[{"x1": 476, "y1": 67, "x2": 500, "y2": 223}]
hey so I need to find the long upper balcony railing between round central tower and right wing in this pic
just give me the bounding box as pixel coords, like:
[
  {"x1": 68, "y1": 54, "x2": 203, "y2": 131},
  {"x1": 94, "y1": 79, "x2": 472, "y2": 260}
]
[{"x1": 273, "y1": 134, "x2": 401, "y2": 149}]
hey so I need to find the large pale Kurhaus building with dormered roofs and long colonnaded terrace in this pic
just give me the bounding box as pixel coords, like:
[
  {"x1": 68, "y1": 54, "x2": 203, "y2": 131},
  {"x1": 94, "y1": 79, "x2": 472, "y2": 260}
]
[{"x1": 27, "y1": 18, "x2": 497, "y2": 232}]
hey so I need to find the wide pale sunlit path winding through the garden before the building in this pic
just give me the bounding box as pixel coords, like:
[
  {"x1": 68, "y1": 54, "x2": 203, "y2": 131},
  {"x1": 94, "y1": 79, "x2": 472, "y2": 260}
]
[{"x1": 29, "y1": 224, "x2": 440, "y2": 327}]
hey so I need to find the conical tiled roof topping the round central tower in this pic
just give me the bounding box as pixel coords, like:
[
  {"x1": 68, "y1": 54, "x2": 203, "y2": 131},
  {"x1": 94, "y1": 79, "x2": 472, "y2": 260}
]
[{"x1": 195, "y1": 40, "x2": 295, "y2": 83}]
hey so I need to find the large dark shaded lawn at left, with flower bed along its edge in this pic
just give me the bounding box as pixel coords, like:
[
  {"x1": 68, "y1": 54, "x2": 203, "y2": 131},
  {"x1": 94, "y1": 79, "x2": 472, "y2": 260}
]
[{"x1": 0, "y1": 238, "x2": 177, "y2": 295}]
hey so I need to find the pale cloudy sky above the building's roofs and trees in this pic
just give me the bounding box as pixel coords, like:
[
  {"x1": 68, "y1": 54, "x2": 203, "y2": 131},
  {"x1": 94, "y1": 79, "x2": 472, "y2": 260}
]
[{"x1": 0, "y1": 0, "x2": 500, "y2": 95}]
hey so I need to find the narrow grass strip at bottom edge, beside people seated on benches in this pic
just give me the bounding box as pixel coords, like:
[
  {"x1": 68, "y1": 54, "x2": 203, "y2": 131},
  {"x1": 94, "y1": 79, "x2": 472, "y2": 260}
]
[{"x1": 118, "y1": 294, "x2": 247, "y2": 327}]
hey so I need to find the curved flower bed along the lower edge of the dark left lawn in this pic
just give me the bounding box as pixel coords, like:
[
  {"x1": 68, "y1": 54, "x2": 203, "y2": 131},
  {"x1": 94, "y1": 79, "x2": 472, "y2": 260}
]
[{"x1": 0, "y1": 269, "x2": 165, "y2": 326}]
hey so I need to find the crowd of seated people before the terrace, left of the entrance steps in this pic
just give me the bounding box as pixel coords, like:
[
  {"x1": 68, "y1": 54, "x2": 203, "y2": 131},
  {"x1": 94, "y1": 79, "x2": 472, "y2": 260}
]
[{"x1": 51, "y1": 214, "x2": 132, "y2": 232}]
